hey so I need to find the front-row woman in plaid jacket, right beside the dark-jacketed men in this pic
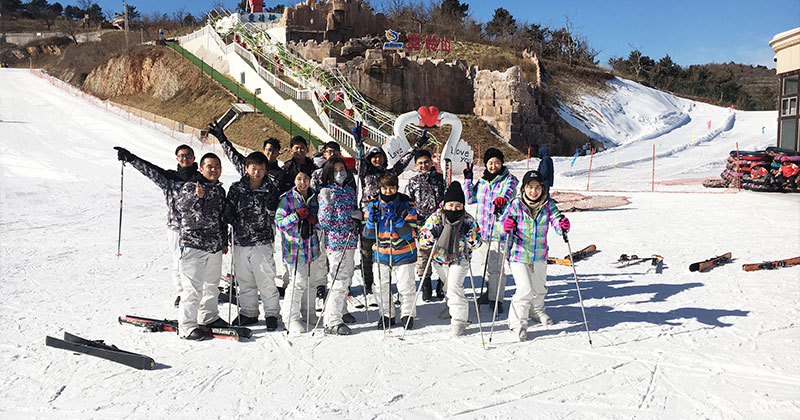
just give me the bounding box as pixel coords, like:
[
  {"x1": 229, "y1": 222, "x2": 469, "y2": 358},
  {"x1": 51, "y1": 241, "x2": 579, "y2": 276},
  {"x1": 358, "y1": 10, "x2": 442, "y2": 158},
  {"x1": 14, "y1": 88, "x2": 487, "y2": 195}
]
[{"x1": 275, "y1": 169, "x2": 320, "y2": 333}]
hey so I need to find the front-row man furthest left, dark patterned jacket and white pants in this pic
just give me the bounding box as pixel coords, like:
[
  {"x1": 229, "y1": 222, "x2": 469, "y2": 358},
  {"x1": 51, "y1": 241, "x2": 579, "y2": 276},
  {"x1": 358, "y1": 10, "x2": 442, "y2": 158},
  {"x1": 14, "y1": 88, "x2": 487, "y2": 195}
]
[{"x1": 175, "y1": 153, "x2": 228, "y2": 339}]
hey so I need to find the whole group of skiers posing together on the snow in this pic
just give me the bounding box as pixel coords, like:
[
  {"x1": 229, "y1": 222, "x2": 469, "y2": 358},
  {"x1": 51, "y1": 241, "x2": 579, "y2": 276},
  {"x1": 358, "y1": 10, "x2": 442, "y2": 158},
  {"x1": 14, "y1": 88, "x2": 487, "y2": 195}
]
[{"x1": 115, "y1": 123, "x2": 569, "y2": 340}]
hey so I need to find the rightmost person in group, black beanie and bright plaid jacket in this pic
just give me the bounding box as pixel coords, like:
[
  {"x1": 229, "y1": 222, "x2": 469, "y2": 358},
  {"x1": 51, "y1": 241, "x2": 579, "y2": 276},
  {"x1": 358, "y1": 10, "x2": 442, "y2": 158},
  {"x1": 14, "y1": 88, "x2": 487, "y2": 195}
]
[{"x1": 502, "y1": 171, "x2": 569, "y2": 341}]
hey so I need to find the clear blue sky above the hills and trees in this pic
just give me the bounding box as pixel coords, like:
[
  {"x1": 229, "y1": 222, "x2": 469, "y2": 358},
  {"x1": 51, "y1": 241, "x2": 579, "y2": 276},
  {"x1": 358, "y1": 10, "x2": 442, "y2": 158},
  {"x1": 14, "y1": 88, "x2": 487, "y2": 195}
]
[{"x1": 73, "y1": 0, "x2": 800, "y2": 68}]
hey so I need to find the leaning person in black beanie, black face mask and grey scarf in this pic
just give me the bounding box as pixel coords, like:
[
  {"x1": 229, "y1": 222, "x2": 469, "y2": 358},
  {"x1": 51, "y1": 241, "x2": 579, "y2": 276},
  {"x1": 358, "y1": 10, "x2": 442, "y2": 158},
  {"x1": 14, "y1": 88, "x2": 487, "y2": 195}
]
[{"x1": 417, "y1": 181, "x2": 481, "y2": 337}]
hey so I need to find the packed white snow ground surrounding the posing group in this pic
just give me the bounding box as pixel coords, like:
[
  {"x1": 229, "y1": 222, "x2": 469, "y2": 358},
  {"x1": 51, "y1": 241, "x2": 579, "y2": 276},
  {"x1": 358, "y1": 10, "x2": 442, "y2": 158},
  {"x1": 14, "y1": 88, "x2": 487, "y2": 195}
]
[{"x1": 0, "y1": 69, "x2": 800, "y2": 419}]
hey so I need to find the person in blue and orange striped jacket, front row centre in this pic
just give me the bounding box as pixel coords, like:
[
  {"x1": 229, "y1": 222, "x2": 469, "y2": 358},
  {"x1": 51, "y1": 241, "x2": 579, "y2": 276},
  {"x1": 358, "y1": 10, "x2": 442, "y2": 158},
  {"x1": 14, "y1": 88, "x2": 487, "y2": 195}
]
[{"x1": 364, "y1": 172, "x2": 417, "y2": 329}]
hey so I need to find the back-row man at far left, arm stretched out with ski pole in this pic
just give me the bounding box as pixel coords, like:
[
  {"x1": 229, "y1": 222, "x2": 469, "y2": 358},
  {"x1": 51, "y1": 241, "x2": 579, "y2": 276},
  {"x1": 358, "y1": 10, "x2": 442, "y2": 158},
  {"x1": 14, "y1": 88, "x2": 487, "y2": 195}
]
[{"x1": 114, "y1": 144, "x2": 197, "y2": 308}]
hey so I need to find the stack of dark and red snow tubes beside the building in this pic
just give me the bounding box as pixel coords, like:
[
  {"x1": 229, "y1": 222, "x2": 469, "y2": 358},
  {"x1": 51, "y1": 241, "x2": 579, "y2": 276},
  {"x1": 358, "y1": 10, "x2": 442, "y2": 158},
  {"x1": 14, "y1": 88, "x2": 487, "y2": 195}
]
[{"x1": 703, "y1": 147, "x2": 800, "y2": 192}]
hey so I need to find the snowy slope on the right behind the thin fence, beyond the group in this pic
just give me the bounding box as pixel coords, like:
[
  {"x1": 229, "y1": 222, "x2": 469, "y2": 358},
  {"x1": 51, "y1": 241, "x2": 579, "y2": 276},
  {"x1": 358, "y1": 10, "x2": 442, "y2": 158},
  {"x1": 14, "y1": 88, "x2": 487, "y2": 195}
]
[{"x1": 554, "y1": 78, "x2": 776, "y2": 191}]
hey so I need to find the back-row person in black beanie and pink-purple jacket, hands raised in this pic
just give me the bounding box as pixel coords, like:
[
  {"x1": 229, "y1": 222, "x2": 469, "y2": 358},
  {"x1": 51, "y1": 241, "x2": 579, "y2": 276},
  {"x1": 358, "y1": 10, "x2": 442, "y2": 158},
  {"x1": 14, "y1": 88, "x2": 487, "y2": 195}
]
[{"x1": 464, "y1": 147, "x2": 519, "y2": 313}]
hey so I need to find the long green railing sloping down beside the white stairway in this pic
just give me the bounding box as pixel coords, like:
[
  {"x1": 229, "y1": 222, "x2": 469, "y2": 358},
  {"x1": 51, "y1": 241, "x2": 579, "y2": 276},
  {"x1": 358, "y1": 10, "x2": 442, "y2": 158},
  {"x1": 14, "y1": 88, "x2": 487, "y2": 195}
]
[{"x1": 167, "y1": 41, "x2": 324, "y2": 149}]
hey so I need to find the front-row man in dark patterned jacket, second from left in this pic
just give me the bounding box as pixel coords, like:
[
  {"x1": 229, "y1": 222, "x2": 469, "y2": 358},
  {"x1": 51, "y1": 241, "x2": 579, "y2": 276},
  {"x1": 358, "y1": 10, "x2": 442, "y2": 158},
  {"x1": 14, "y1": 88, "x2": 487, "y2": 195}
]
[{"x1": 228, "y1": 152, "x2": 280, "y2": 331}]
